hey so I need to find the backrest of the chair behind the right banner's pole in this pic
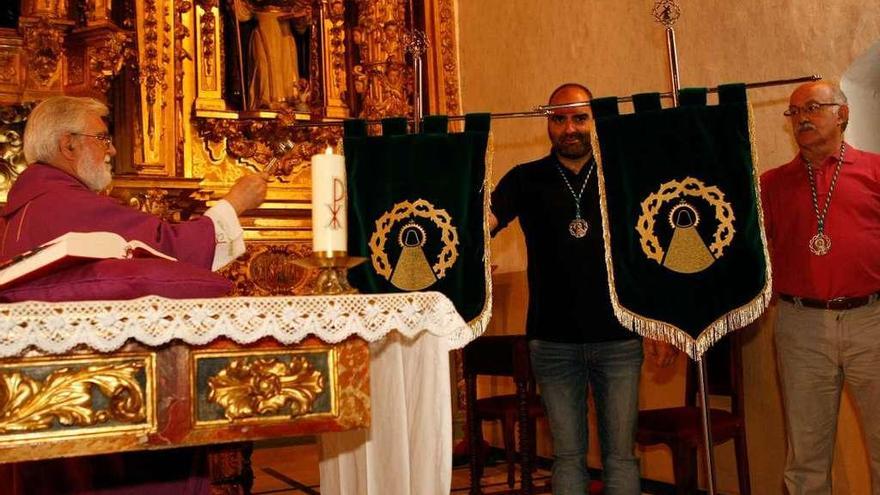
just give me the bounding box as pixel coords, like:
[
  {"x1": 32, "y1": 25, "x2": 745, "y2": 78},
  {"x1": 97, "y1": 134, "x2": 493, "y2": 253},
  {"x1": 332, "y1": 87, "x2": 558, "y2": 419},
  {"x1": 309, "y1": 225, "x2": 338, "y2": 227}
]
[{"x1": 685, "y1": 330, "x2": 745, "y2": 415}]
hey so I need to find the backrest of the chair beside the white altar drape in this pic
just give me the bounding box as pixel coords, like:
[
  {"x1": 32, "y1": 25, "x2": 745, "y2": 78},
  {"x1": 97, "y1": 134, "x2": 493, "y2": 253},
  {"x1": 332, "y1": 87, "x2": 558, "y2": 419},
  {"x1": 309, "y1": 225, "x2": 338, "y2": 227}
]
[{"x1": 462, "y1": 335, "x2": 534, "y2": 388}]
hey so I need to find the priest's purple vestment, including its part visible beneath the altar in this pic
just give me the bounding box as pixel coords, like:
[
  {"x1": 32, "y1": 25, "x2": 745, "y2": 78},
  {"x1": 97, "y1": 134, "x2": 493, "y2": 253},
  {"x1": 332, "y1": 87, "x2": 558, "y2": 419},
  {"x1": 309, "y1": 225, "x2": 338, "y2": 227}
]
[{"x1": 0, "y1": 163, "x2": 215, "y2": 495}]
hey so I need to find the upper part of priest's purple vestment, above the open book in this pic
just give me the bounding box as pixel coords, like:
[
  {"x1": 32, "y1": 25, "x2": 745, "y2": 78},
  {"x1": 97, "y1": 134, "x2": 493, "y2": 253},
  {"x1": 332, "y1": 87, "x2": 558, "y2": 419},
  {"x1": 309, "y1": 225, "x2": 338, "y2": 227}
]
[{"x1": 0, "y1": 163, "x2": 215, "y2": 270}]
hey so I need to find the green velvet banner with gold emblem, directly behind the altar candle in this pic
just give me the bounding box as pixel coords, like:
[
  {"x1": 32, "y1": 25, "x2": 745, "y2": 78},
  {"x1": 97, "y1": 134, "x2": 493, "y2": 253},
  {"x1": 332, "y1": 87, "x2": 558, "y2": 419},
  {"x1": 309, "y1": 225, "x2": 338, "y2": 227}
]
[{"x1": 344, "y1": 114, "x2": 491, "y2": 332}]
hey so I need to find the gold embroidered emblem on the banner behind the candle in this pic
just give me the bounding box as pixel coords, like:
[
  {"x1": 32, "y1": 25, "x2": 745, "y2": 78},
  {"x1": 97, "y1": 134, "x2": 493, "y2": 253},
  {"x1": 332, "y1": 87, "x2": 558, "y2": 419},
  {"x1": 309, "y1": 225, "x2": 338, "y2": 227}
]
[{"x1": 370, "y1": 199, "x2": 458, "y2": 291}]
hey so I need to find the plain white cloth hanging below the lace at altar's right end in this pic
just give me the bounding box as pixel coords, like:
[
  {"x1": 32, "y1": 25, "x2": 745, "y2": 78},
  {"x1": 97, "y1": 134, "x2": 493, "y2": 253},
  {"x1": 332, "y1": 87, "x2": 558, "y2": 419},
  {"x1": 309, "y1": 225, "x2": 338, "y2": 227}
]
[{"x1": 320, "y1": 333, "x2": 452, "y2": 495}]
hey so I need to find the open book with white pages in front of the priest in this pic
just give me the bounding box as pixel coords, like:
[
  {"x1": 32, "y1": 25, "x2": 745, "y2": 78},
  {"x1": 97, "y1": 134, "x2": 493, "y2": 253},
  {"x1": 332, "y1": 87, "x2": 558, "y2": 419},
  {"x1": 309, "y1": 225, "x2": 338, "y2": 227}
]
[{"x1": 0, "y1": 232, "x2": 177, "y2": 287}]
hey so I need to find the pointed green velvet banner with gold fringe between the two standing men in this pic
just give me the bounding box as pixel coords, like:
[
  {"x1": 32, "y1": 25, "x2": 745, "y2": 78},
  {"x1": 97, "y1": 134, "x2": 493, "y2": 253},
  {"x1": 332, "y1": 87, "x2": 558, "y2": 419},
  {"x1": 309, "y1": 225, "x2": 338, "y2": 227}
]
[{"x1": 592, "y1": 85, "x2": 770, "y2": 359}]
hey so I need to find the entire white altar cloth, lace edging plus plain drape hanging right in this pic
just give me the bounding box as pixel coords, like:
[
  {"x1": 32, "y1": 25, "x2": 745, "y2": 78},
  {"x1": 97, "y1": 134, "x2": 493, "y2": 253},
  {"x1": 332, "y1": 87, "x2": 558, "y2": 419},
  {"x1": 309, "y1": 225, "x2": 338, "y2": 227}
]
[{"x1": 0, "y1": 292, "x2": 474, "y2": 495}]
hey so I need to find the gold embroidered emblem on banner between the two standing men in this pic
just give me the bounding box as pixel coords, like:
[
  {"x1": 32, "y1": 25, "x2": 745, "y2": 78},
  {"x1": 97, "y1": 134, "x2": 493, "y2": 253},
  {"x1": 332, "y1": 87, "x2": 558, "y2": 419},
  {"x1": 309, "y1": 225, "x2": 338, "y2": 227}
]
[{"x1": 635, "y1": 177, "x2": 736, "y2": 273}]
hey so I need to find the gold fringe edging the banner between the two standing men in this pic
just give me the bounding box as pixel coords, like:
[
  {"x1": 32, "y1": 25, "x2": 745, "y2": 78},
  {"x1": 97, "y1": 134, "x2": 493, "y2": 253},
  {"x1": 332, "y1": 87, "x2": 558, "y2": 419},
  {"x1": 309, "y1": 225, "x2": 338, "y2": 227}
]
[{"x1": 591, "y1": 103, "x2": 773, "y2": 360}]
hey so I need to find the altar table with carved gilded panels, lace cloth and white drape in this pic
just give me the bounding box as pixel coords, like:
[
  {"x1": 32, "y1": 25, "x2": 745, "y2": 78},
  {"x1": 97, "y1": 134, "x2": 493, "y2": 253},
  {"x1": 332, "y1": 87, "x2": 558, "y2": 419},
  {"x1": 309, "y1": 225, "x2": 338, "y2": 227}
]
[{"x1": 0, "y1": 292, "x2": 472, "y2": 494}]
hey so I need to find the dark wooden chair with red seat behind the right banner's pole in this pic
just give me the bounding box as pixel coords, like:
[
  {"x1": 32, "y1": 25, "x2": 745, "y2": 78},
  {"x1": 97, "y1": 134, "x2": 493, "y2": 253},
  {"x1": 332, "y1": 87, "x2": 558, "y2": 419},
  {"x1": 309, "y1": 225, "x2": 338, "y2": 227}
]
[{"x1": 636, "y1": 332, "x2": 751, "y2": 495}]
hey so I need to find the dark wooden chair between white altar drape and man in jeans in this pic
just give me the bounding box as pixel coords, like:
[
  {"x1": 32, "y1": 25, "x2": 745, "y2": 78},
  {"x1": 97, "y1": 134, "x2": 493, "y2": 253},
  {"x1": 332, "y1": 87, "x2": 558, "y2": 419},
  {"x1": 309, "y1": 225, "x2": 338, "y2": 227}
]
[{"x1": 462, "y1": 335, "x2": 544, "y2": 494}]
